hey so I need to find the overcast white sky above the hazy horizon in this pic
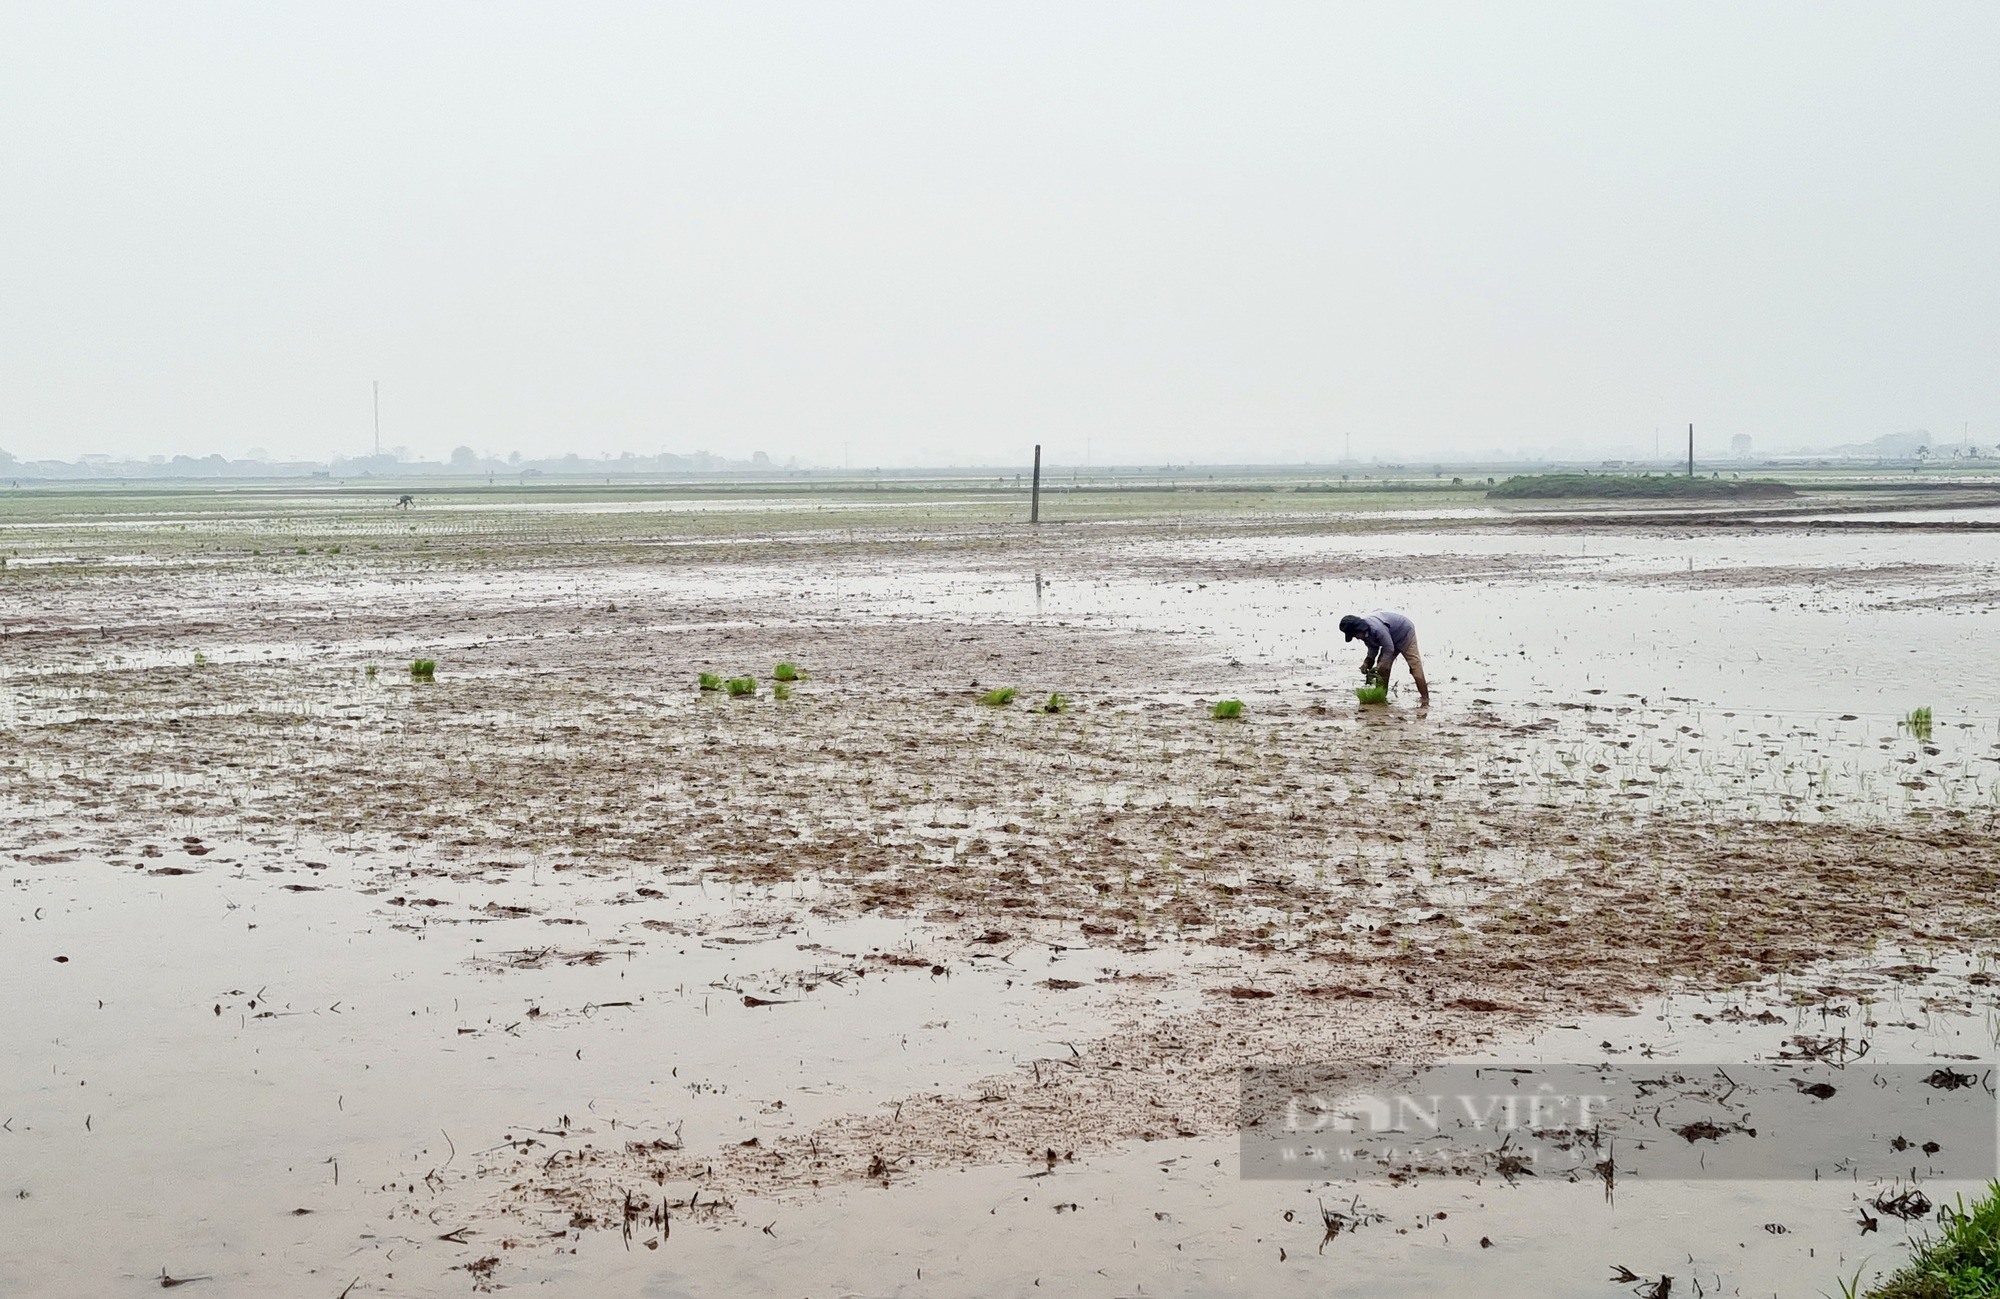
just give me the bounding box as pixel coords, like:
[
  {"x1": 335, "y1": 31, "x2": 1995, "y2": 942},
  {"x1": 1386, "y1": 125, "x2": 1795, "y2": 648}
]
[{"x1": 0, "y1": 0, "x2": 2000, "y2": 466}]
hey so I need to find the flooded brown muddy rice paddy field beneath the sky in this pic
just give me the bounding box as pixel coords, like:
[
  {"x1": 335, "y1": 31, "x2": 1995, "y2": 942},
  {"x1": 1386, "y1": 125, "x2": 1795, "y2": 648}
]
[{"x1": 0, "y1": 485, "x2": 2000, "y2": 1295}]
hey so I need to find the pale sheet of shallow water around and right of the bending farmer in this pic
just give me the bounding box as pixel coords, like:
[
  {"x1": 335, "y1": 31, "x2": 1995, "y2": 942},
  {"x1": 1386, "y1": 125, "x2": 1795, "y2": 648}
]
[{"x1": 860, "y1": 534, "x2": 2000, "y2": 817}]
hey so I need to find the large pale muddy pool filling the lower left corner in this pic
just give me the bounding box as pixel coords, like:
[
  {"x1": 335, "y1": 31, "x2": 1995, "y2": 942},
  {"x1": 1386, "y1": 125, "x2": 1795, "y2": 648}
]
[{"x1": 0, "y1": 841, "x2": 1184, "y2": 1295}]
